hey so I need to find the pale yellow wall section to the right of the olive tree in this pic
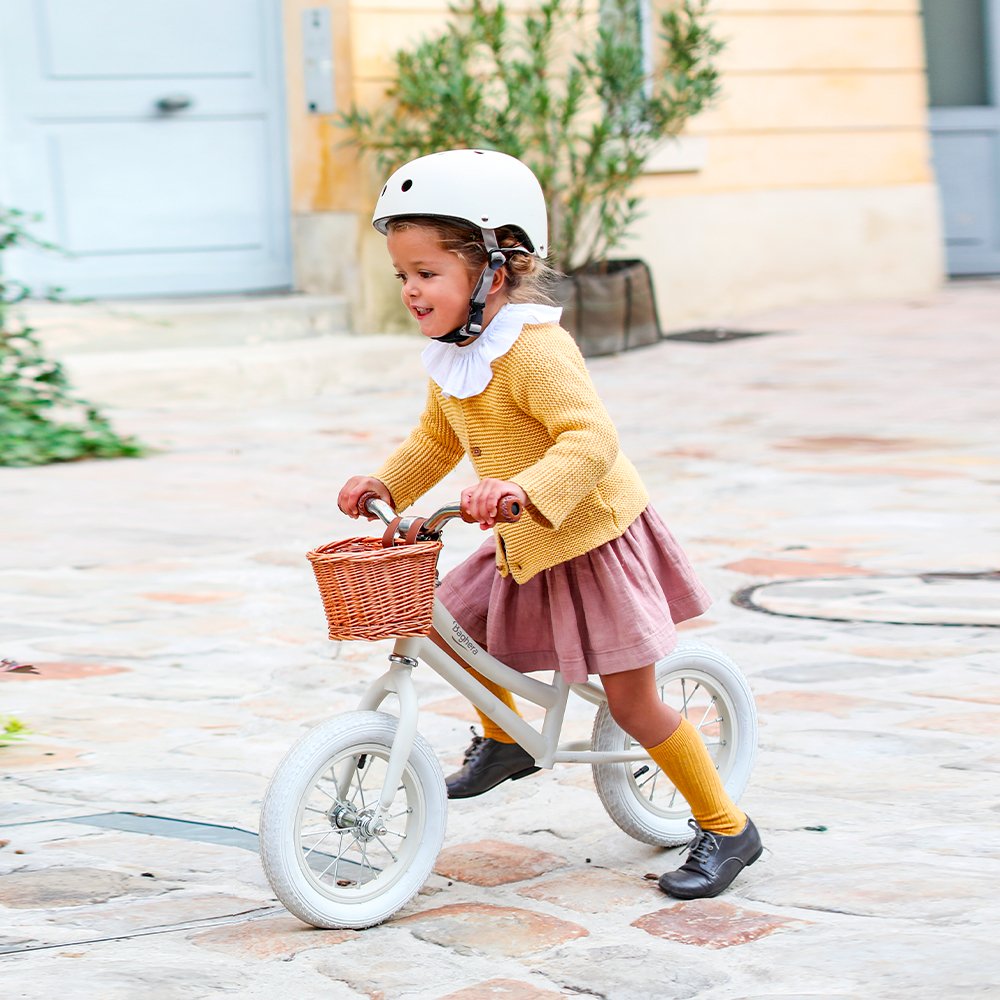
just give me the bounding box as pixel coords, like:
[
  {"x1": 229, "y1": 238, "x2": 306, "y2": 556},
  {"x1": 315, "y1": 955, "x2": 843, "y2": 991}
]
[{"x1": 627, "y1": 0, "x2": 944, "y2": 327}]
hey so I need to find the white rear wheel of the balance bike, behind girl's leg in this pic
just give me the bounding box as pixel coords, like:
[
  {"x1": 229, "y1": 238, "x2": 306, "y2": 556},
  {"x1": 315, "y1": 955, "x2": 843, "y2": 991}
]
[{"x1": 592, "y1": 643, "x2": 757, "y2": 847}]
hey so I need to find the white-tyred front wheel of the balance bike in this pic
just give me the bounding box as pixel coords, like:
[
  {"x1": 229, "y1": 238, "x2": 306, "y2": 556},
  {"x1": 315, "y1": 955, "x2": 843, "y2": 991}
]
[{"x1": 260, "y1": 712, "x2": 448, "y2": 928}]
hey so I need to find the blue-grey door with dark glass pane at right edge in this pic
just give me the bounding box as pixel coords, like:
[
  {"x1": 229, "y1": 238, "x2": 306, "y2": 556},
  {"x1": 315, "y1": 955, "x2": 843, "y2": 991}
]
[{"x1": 924, "y1": 0, "x2": 1000, "y2": 274}]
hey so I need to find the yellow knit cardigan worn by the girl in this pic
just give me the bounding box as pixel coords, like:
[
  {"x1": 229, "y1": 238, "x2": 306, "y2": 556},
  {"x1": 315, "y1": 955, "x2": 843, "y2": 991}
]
[{"x1": 375, "y1": 323, "x2": 649, "y2": 583}]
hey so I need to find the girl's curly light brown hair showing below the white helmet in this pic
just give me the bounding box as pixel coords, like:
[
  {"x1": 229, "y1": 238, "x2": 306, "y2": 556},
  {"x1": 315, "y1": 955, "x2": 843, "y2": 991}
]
[{"x1": 386, "y1": 215, "x2": 558, "y2": 305}]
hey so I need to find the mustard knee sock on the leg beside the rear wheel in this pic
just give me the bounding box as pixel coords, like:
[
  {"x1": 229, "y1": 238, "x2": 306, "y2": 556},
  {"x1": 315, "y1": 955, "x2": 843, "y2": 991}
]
[{"x1": 646, "y1": 719, "x2": 747, "y2": 837}]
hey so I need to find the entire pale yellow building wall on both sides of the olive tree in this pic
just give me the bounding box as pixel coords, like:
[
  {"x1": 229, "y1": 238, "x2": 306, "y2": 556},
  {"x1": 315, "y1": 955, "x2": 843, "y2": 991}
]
[{"x1": 285, "y1": 0, "x2": 943, "y2": 330}]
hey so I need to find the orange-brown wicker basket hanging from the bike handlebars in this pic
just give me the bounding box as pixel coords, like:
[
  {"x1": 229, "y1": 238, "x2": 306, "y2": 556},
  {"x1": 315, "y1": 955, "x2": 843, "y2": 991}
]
[{"x1": 308, "y1": 538, "x2": 441, "y2": 639}]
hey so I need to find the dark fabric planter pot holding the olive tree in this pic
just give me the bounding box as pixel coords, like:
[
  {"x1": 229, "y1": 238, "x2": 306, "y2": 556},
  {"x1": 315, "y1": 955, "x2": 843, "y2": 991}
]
[{"x1": 553, "y1": 260, "x2": 661, "y2": 358}]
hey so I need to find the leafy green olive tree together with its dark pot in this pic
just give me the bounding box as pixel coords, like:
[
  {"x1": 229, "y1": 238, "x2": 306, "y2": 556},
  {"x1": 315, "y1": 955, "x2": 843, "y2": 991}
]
[{"x1": 340, "y1": 0, "x2": 721, "y2": 355}]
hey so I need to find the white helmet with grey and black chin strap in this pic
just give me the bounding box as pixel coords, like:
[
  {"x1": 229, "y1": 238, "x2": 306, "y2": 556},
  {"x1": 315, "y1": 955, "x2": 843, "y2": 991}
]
[{"x1": 372, "y1": 149, "x2": 548, "y2": 344}]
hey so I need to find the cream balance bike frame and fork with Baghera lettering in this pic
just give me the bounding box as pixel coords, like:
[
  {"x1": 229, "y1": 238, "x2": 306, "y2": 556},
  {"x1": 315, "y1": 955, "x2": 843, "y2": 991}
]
[{"x1": 356, "y1": 597, "x2": 649, "y2": 815}]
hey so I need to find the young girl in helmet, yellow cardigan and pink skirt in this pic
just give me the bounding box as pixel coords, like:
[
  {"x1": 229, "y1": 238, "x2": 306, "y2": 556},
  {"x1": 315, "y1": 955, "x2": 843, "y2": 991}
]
[{"x1": 338, "y1": 149, "x2": 762, "y2": 899}]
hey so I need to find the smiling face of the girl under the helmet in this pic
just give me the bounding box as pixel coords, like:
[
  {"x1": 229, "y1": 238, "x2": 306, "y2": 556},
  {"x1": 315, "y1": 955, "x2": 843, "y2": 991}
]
[{"x1": 387, "y1": 227, "x2": 498, "y2": 337}]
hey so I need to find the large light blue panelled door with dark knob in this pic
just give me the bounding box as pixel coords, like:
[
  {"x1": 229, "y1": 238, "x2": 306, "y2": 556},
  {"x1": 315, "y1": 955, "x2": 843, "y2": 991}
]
[{"x1": 0, "y1": 0, "x2": 291, "y2": 296}]
